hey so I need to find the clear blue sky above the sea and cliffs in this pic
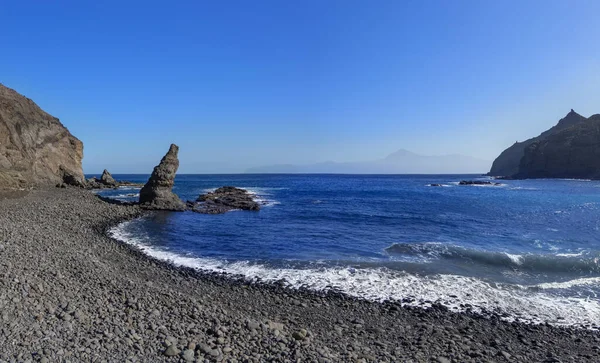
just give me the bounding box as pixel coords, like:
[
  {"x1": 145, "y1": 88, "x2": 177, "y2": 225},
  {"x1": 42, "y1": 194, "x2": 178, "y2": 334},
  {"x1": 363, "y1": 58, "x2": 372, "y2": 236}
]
[{"x1": 0, "y1": 0, "x2": 600, "y2": 173}]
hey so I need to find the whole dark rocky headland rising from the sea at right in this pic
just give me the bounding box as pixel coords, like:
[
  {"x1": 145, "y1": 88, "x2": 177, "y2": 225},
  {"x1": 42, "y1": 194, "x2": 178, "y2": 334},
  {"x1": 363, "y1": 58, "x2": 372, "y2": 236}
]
[{"x1": 489, "y1": 110, "x2": 600, "y2": 179}]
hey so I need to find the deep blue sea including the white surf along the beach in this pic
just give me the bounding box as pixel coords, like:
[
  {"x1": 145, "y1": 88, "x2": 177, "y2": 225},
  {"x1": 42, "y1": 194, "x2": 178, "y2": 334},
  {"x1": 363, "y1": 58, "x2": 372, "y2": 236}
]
[{"x1": 99, "y1": 174, "x2": 600, "y2": 327}]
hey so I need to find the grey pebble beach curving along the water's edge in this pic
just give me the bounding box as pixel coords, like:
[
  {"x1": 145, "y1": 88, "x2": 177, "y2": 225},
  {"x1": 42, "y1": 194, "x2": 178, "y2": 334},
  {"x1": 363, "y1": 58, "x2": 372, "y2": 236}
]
[{"x1": 0, "y1": 188, "x2": 600, "y2": 362}]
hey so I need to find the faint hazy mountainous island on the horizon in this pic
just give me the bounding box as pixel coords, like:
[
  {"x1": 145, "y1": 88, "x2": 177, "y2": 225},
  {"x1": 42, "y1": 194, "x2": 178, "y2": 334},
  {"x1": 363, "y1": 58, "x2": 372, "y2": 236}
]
[{"x1": 246, "y1": 149, "x2": 490, "y2": 174}]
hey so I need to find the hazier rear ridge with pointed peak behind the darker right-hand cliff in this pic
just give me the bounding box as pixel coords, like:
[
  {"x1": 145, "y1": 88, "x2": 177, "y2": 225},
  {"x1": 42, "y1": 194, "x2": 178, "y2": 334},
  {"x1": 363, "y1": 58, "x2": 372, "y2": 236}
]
[{"x1": 489, "y1": 110, "x2": 591, "y2": 177}]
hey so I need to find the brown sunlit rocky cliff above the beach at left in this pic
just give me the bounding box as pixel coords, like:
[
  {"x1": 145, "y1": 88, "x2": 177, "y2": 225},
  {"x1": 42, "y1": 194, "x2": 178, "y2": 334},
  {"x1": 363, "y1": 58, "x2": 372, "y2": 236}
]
[{"x1": 0, "y1": 84, "x2": 84, "y2": 188}]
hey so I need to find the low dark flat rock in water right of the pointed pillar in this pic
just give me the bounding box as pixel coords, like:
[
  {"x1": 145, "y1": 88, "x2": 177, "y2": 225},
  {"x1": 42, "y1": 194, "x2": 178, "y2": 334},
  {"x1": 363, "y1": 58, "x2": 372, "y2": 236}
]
[{"x1": 190, "y1": 187, "x2": 260, "y2": 214}]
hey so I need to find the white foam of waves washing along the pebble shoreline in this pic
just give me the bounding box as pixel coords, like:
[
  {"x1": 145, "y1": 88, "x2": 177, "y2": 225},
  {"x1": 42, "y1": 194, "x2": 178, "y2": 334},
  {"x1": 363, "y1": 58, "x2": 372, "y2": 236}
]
[{"x1": 109, "y1": 222, "x2": 600, "y2": 325}]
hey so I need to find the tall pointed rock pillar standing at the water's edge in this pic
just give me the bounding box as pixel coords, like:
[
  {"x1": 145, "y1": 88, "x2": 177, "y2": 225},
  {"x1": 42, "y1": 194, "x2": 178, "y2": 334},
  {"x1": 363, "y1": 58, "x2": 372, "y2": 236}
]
[{"x1": 140, "y1": 144, "x2": 186, "y2": 211}]
